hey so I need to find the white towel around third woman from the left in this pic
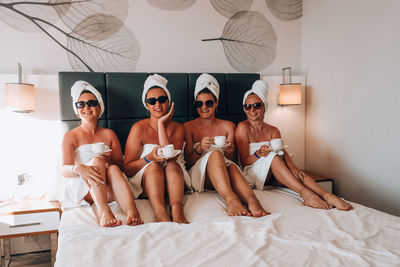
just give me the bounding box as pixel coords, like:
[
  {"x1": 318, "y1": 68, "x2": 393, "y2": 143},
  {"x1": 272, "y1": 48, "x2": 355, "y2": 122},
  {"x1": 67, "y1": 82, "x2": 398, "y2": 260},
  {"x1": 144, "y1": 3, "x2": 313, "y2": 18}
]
[{"x1": 189, "y1": 143, "x2": 242, "y2": 193}]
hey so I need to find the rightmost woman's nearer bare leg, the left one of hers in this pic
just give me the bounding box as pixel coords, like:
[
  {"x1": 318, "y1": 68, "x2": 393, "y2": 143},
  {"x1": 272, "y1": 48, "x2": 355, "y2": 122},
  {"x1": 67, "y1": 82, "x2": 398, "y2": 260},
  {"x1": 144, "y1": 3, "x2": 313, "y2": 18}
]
[{"x1": 271, "y1": 157, "x2": 332, "y2": 209}]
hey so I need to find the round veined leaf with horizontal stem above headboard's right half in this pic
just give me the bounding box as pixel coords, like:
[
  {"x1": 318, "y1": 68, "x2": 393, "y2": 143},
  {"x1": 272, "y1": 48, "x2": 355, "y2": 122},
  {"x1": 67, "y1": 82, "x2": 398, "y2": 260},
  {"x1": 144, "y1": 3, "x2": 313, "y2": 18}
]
[{"x1": 202, "y1": 11, "x2": 277, "y2": 72}]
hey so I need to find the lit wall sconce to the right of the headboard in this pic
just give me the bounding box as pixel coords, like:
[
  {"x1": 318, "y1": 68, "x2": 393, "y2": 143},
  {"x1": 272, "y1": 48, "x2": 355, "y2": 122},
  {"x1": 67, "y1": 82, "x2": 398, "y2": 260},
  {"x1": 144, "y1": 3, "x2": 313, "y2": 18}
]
[{"x1": 278, "y1": 67, "x2": 301, "y2": 106}]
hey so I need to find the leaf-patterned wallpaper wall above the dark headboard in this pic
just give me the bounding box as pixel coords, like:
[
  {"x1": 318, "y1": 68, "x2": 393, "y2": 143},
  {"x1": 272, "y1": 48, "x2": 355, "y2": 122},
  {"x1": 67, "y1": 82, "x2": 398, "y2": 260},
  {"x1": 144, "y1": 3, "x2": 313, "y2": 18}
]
[{"x1": 0, "y1": 0, "x2": 302, "y2": 75}]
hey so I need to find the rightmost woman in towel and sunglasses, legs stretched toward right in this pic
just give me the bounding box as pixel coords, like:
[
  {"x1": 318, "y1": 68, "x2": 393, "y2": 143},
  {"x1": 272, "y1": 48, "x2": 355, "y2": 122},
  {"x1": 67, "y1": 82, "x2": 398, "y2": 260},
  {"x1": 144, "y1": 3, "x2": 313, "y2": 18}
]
[{"x1": 235, "y1": 80, "x2": 352, "y2": 210}]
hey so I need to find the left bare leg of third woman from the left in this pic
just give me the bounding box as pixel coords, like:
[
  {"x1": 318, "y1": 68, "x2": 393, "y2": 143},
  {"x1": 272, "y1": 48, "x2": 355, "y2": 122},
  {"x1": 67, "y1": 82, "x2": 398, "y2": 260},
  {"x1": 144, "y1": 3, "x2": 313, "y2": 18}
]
[{"x1": 206, "y1": 150, "x2": 251, "y2": 216}]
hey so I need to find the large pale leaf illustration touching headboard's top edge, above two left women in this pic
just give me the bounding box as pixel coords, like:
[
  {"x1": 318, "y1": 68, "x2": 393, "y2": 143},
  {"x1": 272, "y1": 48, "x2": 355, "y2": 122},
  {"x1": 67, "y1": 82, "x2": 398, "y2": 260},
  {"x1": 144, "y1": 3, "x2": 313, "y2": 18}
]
[{"x1": 67, "y1": 14, "x2": 140, "y2": 71}]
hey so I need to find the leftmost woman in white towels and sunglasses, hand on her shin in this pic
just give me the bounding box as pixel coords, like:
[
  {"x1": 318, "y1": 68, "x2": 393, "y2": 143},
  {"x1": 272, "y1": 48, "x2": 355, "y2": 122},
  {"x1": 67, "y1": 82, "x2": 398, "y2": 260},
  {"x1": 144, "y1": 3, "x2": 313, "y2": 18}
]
[{"x1": 62, "y1": 81, "x2": 143, "y2": 227}]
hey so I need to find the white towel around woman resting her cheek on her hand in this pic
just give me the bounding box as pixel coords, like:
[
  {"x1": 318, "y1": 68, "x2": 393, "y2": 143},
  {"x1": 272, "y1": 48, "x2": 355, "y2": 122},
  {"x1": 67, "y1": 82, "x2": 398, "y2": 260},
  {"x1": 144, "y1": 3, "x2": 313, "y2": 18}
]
[{"x1": 128, "y1": 144, "x2": 191, "y2": 198}]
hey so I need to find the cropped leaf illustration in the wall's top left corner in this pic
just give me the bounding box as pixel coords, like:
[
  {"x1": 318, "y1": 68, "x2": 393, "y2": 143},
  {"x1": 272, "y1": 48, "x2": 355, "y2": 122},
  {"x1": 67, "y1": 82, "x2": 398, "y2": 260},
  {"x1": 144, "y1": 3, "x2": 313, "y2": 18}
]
[{"x1": 0, "y1": 0, "x2": 59, "y2": 32}]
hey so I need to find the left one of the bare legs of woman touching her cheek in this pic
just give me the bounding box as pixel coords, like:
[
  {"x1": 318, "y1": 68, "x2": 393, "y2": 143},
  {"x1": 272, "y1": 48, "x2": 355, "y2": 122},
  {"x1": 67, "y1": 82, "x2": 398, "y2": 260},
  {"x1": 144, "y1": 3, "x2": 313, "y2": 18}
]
[{"x1": 142, "y1": 162, "x2": 171, "y2": 222}]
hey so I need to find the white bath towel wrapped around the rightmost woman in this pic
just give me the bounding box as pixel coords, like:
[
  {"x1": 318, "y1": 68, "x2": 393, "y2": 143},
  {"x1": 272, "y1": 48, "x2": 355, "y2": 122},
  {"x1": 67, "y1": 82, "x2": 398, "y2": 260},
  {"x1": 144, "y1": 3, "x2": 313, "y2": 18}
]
[{"x1": 243, "y1": 141, "x2": 278, "y2": 190}]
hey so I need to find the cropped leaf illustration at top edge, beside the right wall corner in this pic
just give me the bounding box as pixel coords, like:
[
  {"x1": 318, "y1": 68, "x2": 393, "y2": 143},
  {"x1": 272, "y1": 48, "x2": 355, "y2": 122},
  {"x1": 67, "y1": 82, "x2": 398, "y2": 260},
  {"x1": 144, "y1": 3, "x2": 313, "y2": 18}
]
[{"x1": 265, "y1": 0, "x2": 303, "y2": 20}]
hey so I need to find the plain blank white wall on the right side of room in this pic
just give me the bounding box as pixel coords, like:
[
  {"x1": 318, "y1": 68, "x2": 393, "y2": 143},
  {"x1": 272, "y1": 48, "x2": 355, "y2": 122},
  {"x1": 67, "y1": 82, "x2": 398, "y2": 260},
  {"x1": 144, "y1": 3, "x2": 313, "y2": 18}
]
[{"x1": 301, "y1": 0, "x2": 400, "y2": 215}]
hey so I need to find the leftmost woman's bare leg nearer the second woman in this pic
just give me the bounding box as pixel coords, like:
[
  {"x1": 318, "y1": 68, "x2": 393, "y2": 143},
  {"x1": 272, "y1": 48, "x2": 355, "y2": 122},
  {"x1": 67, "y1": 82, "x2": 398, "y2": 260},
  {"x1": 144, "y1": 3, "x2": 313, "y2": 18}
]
[{"x1": 107, "y1": 168, "x2": 143, "y2": 225}]
